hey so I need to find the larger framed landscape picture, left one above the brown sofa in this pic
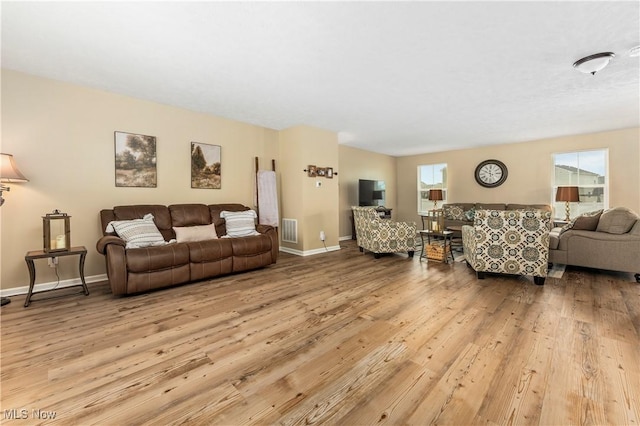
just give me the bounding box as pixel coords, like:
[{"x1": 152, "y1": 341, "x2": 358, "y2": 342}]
[{"x1": 114, "y1": 132, "x2": 158, "y2": 188}]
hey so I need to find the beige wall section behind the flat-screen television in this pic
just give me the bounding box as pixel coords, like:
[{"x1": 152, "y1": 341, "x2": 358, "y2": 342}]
[{"x1": 339, "y1": 145, "x2": 396, "y2": 238}]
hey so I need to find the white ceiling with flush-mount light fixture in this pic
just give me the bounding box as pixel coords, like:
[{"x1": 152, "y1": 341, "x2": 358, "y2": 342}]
[{"x1": 1, "y1": 1, "x2": 640, "y2": 156}]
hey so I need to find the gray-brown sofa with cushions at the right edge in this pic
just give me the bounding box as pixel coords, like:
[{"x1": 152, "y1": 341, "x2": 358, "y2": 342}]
[{"x1": 549, "y1": 207, "x2": 640, "y2": 282}]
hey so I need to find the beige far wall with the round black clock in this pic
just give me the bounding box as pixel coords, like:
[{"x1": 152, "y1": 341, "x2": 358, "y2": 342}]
[{"x1": 397, "y1": 128, "x2": 640, "y2": 220}]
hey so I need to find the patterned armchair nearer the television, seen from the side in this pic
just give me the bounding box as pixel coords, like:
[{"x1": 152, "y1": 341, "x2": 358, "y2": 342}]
[{"x1": 351, "y1": 207, "x2": 417, "y2": 259}]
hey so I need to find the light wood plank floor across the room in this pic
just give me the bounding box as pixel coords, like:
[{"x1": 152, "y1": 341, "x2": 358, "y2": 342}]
[{"x1": 1, "y1": 241, "x2": 640, "y2": 425}]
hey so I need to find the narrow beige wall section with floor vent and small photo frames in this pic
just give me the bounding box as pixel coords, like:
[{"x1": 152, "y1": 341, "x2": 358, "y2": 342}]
[{"x1": 280, "y1": 126, "x2": 341, "y2": 254}]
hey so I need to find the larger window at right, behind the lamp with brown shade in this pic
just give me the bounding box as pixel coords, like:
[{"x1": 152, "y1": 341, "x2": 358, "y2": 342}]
[{"x1": 551, "y1": 149, "x2": 609, "y2": 218}]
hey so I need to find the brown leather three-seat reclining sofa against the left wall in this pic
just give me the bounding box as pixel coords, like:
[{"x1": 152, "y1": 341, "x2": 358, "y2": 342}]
[{"x1": 96, "y1": 204, "x2": 279, "y2": 295}]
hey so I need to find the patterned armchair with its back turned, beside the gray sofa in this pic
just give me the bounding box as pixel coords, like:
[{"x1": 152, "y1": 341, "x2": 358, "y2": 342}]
[{"x1": 462, "y1": 210, "x2": 551, "y2": 285}]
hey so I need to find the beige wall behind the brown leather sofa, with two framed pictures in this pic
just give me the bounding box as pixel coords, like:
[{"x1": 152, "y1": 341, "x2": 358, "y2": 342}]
[{"x1": 0, "y1": 70, "x2": 278, "y2": 289}]
